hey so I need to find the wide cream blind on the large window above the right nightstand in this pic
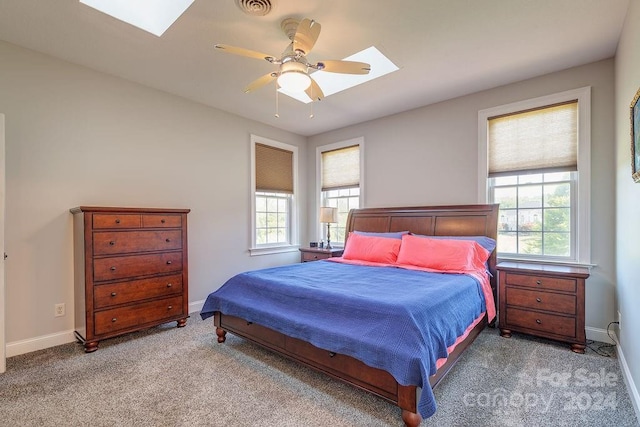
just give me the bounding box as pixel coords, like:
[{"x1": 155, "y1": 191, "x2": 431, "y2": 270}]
[{"x1": 488, "y1": 101, "x2": 578, "y2": 177}]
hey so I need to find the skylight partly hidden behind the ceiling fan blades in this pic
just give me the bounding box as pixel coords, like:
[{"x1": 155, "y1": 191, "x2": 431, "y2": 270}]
[{"x1": 280, "y1": 46, "x2": 399, "y2": 104}]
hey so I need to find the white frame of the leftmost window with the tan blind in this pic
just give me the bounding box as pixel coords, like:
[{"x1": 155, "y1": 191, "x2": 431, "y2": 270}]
[{"x1": 249, "y1": 134, "x2": 300, "y2": 256}]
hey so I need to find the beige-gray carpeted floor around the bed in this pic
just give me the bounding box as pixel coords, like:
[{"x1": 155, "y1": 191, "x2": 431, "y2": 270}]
[{"x1": 0, "y1": 314, "x2": 638, "y2": 427}]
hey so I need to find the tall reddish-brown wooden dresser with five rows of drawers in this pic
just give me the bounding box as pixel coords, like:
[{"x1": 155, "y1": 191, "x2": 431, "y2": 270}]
[{"x1": 71, "y1": 206, "x2": 189, "y2": 353}]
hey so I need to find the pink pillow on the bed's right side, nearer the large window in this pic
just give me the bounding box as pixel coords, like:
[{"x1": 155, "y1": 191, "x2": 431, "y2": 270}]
[{"x1": 397, "y1": 235, "x2": 490, "y2": 272}]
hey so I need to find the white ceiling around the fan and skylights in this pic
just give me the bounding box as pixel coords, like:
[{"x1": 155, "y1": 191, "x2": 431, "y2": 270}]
[{"x1": 0, "y1": 0, "x2": 629, "y2": 136}]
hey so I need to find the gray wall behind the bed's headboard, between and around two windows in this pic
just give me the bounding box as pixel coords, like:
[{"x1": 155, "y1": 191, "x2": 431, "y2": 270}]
[{"x1": 307, "y1": 59, "x2": 616, "y2": 339}]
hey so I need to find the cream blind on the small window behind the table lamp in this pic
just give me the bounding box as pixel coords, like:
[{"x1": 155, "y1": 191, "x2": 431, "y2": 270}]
[{"x1": 322, "y1": 145, "x2": 360, "y2": 191}]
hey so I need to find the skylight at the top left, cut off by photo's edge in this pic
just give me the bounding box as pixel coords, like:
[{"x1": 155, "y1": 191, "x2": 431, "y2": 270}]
[{"x1": 80, "y1": 0, "x2": 194, "y2": 37}]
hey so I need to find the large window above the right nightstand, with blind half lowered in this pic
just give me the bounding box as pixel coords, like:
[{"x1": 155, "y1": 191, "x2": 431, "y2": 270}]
[{"x1": 478, "y1": 88, "x2": 590, "y2": 263}]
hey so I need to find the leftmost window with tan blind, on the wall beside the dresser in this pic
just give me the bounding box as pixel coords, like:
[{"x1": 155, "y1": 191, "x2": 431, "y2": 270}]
[{"x1": 251, "y1": 135, "x2": 298, "y2": 255}]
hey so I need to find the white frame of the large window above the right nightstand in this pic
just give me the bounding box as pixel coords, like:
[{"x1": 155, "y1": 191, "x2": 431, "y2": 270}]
[{"x1": 478, "y1": 86, "x2": 592, "y2": 266}]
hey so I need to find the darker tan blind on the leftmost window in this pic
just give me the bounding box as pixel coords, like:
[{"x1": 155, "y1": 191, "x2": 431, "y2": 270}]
[{"x1": 256, "y1": 144, "x2": 293, "y2": 194}]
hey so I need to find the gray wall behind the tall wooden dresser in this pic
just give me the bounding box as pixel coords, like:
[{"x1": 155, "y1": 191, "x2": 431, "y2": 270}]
[{"x1": 0, "y1": 42, "x2": 306, "y2": 348}]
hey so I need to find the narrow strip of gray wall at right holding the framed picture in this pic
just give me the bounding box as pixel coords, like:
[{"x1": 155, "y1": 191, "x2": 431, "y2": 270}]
[{"x1": 615, "y1": 1, "x2": 640, "y2": 418}]
